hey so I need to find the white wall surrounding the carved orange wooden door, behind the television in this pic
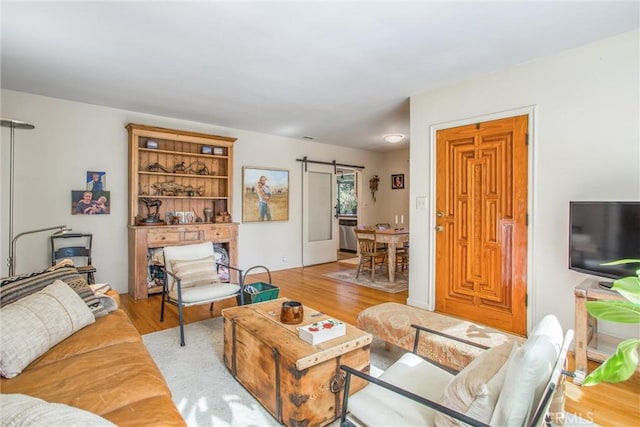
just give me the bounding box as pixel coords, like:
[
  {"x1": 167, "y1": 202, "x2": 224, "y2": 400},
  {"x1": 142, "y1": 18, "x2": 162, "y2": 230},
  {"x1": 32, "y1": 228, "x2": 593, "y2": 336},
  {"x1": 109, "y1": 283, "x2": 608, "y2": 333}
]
[{"x1": 409, "y1": 31, "x2": 640, "y2": 336}]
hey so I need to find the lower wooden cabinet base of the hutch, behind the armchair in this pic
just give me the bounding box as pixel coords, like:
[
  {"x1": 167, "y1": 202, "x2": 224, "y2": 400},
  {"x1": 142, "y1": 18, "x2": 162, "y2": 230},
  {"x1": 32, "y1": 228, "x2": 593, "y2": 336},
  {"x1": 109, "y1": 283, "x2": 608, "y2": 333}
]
[{"x1": 129, "y1": 223, "x2": 238, "y2": 299}]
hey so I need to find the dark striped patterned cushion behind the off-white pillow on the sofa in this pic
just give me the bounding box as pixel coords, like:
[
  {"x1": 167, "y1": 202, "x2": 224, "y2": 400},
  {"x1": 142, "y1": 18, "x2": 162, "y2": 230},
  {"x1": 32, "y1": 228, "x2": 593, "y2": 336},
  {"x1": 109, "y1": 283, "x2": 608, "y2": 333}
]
[{"x1": 0, "y1": 267, "x2": 107, "y2": 318}]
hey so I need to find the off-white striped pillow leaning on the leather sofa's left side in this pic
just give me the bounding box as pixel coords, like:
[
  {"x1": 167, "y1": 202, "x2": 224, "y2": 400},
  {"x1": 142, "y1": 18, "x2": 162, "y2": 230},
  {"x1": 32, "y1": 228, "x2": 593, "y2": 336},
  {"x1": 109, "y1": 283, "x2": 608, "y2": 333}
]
[{"x1": 0, "y1": 280, "x2": 96, "y2": 378}]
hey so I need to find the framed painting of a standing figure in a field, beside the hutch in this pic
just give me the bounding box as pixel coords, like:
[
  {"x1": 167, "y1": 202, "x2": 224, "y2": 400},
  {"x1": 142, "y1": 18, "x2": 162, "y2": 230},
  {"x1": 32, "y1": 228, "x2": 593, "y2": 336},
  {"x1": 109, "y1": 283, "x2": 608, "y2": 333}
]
[{"x1": 242, "y1": 166, "x2": 289, "y2": 222}]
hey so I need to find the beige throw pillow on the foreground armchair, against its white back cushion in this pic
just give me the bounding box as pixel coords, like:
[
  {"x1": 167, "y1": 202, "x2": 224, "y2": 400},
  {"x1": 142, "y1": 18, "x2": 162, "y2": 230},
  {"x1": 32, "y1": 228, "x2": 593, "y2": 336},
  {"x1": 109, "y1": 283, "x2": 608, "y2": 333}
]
[{"x1": 435, "y1": 342, "x2": 517, "y2": 426}]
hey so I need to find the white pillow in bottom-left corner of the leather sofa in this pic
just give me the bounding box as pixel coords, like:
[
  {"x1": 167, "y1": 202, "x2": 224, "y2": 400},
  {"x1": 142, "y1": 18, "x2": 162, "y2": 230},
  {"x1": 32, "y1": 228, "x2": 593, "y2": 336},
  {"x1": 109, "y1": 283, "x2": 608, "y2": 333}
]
[{"x1": 0, "y1": 394, "x2": 115, "y2": 427}]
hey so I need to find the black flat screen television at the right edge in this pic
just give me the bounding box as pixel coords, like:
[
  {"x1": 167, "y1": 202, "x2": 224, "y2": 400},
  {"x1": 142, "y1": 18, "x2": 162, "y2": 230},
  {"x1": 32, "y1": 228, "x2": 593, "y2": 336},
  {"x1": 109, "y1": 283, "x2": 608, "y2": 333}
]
[{"x1": 569, "y1": 202, "x2": 640, "y2": 279}]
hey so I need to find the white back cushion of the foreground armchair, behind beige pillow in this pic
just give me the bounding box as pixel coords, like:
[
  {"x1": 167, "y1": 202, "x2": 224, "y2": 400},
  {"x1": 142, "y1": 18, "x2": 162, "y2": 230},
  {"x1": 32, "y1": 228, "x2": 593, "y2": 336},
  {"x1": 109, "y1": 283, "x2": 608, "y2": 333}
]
[{"x1": 490, "y1": 315, "x2": 563, "y2": 426}]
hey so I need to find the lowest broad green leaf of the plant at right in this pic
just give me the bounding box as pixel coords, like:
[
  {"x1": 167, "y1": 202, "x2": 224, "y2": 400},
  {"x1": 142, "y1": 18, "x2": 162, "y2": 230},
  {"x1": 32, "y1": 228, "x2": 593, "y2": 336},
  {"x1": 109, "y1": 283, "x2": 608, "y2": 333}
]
[{"x1": 582, "y1": 338, "x2": 640, "y2": 386}]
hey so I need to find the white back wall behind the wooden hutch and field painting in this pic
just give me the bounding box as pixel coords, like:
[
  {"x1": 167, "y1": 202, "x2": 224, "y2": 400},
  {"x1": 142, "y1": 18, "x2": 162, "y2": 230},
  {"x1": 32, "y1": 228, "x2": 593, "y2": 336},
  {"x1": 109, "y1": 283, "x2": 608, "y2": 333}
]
[{"x1": 0, "y1": 90, "x2": 384, "y2": 292}]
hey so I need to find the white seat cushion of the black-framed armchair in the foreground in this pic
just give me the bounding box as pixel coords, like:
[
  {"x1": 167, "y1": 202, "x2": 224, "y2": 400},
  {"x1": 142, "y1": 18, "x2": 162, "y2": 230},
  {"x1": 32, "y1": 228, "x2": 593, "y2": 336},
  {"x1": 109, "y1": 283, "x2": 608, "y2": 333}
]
[{"x1": 349, "y1": 353, "x2": 453, "y2": 426}]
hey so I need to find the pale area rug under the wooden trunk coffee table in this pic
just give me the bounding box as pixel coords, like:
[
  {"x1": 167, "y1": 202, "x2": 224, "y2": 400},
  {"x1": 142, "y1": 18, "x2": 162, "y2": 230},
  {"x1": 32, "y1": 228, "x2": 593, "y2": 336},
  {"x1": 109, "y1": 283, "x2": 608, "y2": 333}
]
[{"x1": 142, "y1": 317, "x2": 404, "y2": 426}]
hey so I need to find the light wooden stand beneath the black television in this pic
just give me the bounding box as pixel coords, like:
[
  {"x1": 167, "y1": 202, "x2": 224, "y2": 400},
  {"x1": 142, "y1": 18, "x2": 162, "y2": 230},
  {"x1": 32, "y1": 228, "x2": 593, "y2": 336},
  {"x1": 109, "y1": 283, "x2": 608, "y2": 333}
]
[{"x1": 573, "y1": 279, "x2": 636, "y2": 384}]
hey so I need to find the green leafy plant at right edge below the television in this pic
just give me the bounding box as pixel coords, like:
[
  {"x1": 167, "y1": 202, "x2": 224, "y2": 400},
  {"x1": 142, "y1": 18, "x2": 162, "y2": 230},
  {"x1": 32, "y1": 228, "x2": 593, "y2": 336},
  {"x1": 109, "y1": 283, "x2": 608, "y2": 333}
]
[{"x1": 583, "y1": 259, "x2": 640, "y2": 386}]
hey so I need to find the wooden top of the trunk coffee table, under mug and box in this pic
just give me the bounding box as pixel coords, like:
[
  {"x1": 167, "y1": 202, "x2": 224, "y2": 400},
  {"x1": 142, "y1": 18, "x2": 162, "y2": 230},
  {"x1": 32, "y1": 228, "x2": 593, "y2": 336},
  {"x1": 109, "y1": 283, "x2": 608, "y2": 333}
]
[{"x1": 222, "y1": 298, "x2": 373, "y2": 370}]
